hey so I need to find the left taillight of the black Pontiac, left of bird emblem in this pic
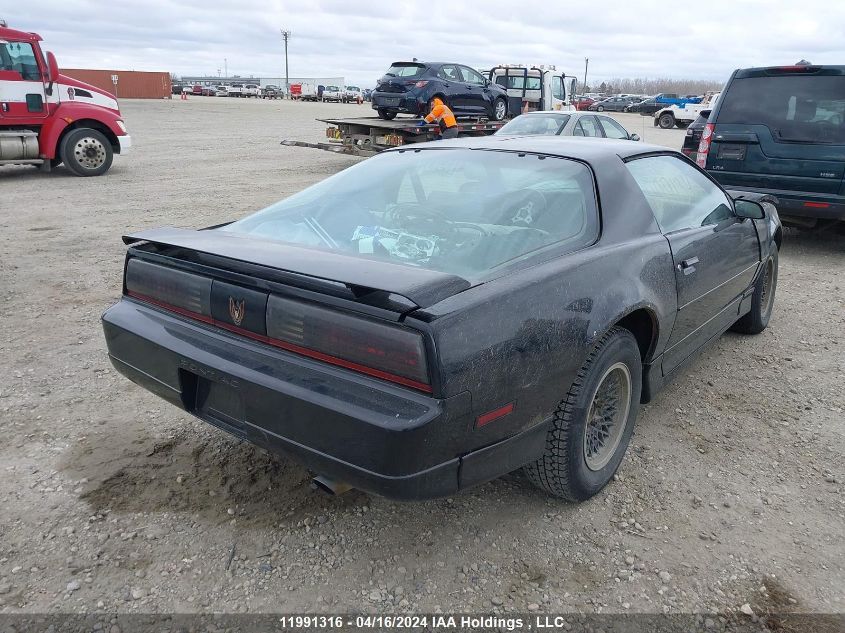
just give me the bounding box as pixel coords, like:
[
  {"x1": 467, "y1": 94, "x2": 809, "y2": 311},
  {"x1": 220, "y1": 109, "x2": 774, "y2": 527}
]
[{"x1": 126, "y1": 259, "x2": 211, "y2": 321}]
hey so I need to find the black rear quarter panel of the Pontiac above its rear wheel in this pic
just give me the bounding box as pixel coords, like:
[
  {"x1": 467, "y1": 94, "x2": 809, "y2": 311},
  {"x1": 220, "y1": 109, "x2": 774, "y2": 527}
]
[{"x1": 413, "y1": 157, "x2": 677, "y2": 445}]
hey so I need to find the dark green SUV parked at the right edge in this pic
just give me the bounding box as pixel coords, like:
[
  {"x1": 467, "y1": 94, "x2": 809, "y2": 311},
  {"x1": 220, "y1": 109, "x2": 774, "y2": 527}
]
[{"x1": 696, "y1": 62, "x2": 845, "y2": 227}]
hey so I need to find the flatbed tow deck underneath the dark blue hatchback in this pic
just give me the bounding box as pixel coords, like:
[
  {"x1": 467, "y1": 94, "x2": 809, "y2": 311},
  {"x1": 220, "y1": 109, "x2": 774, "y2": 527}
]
[{"x1": 282, "y1": 117, "x2": 506, "y2": 156}]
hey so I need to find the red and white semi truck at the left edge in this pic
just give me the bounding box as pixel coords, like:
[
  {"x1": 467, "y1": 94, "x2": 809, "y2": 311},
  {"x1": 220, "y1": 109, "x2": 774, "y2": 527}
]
[{"x1": 0, "y1": 20, "x2": 132, "y2": 176}]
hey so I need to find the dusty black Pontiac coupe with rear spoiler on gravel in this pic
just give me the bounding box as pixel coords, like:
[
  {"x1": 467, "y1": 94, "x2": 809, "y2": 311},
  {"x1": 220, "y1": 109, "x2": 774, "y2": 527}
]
[{"x1": 103, "y1": 136, "x2": 781, "y2": 500}]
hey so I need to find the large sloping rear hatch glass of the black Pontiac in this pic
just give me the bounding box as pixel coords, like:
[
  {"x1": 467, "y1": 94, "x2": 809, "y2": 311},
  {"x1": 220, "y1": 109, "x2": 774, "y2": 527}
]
[{"x1": 219, "y1": 149, "x2": 598, "y2": 279}]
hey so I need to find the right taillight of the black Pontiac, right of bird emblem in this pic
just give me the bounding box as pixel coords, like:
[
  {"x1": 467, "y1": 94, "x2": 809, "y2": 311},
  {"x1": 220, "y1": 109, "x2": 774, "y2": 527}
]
[{"x1": 267, "y1": 296, "x2": 431, "y2": 392}]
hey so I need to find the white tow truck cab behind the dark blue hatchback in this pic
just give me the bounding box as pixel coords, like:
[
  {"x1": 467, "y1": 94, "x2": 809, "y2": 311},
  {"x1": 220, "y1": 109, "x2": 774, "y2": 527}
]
[{"x1": 482, "y1": 64, "x2": 575, "y2": 114}]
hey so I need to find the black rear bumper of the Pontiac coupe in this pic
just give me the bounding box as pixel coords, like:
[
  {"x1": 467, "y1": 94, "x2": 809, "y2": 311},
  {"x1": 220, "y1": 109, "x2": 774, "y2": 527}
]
[{"x1": 103, "y1": 299, "x2": 546, "y2": 499}]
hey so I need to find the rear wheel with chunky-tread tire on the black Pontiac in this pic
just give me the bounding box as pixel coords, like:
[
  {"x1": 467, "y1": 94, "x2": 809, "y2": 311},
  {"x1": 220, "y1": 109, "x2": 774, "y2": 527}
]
[{"x1": 524, "y1": 327, "x2": 642, "y2": 501}]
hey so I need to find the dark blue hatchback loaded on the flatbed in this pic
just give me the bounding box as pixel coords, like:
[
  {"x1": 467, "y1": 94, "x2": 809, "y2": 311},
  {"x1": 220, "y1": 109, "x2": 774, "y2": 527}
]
[{"x1": 372, "y1": 62, "x2": 508, "y2": 121}]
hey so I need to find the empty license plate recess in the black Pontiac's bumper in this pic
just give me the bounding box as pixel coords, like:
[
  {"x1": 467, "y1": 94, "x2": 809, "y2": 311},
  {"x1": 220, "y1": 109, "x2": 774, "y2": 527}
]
[{"x1": 181, "y1": 369, "x2": 246, "y2": 437}]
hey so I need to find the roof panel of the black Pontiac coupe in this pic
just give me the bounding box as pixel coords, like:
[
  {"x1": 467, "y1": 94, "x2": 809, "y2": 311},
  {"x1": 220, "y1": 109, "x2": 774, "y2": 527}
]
[{"x1": 389, "y1": 134, "x2": 680, "y2": 163}]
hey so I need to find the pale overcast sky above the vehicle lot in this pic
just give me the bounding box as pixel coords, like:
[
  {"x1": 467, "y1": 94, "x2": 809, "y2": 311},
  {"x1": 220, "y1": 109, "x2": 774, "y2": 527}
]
[{"x1": 9, "y1": 0, "x2": 845, "y2": 87}]
